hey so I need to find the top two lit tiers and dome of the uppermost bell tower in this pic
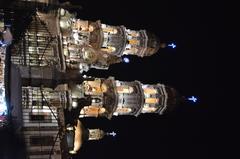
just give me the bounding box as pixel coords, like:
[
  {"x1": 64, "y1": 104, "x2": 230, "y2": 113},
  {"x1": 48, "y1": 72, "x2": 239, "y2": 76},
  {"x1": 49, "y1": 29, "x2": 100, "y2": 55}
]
[{"x1": 98, "y1": 24, "x2": 166, "y2": 57}]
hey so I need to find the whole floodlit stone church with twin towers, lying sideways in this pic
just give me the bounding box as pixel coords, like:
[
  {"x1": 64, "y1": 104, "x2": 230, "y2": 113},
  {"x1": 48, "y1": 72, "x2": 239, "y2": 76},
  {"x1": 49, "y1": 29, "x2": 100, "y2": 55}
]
[{"x1": 0, "y1": 4, "x2": 181, "y2": 158}]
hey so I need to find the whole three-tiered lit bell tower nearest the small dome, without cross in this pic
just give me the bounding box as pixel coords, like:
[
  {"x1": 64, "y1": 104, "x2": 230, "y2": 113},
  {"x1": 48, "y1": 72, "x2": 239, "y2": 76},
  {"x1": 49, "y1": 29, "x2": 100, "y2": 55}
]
[{"x1": 70, "y1": 77, "x2": 181, "y2": 119}]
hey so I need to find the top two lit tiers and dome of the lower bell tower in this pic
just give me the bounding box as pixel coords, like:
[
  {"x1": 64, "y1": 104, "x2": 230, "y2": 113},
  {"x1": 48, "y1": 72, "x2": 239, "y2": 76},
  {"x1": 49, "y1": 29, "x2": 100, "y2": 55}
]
[{"x1": 113, "y1": 80, "x2": 181, "y2": 116}]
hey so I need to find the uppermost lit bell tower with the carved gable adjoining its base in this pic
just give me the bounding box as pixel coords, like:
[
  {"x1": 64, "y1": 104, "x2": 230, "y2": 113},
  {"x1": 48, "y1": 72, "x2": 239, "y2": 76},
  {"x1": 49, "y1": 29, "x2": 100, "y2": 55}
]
[{"x1": 59, "y1": 9, "x2": 166, "y2": 72}]
